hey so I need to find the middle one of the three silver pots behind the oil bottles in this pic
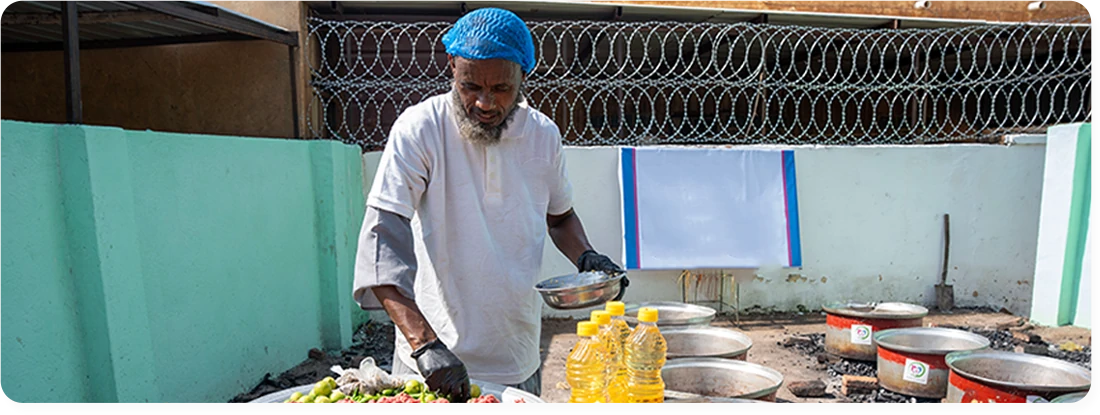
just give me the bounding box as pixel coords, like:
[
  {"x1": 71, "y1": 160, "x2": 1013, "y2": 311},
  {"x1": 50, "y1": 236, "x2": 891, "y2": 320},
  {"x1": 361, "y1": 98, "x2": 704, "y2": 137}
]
[{"x1": 661, "y1": 327, "x2": 752, "y2": 360}]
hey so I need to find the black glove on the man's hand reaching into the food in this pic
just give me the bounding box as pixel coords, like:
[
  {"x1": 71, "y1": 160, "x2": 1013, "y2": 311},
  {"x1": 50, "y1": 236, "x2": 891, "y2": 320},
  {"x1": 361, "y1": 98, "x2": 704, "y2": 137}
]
[{"x1": 413, "y1": 339, "x2": 470, "y2": 403}]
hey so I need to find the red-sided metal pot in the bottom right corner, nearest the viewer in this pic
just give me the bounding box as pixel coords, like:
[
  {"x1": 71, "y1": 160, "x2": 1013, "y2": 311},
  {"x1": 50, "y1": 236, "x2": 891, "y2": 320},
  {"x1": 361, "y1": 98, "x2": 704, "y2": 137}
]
[{"x1": 945, "y1": 350, "x2": 1092, "y2": 404}]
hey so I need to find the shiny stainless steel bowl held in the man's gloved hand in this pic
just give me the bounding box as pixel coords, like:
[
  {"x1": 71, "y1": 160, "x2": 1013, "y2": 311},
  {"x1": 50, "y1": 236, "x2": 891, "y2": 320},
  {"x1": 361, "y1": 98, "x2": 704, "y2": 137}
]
[{"x1": 535, "y1": 271, "x2": 626, "y2": 309}]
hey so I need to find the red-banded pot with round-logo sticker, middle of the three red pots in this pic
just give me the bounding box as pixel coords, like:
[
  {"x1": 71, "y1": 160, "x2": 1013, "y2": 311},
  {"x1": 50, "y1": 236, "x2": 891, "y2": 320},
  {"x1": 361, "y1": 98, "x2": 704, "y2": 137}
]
[{"x1": 875, "y1": 327, "x2": 990, "y2": 398}]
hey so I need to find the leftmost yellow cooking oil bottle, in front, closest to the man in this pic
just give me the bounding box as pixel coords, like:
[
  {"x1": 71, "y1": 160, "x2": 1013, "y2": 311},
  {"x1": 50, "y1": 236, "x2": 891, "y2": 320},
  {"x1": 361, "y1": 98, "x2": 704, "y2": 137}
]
[{"x1": 565, "y1": 320, "x2": 611, "y2": 403}]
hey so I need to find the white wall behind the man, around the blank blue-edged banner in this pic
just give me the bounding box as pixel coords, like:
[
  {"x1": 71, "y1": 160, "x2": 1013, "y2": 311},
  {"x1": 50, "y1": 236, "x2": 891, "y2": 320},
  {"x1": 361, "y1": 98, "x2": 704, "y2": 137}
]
[{"x1": 364, "y1": 143, "x2": 1044, "y2": 316}]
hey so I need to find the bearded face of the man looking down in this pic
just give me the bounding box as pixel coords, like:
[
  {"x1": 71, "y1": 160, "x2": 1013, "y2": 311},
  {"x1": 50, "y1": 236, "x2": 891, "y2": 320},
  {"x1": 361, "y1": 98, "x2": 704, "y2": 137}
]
[{"x1": 449, "y1": 56, "x2": 524, "y2": 142}]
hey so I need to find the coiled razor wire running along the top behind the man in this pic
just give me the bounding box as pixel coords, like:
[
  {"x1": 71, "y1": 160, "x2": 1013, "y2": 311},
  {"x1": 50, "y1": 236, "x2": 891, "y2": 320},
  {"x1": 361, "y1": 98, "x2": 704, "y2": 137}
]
[{"x1": 307, "y1": 18, "x2": 1092, "y2": 149}]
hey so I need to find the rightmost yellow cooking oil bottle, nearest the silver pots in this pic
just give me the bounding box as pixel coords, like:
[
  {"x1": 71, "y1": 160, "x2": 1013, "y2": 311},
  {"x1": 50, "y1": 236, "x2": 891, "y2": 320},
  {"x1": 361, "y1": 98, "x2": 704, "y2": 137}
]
[{"x1": 625, "y1": 307, "x2": 668, "y2": 403}]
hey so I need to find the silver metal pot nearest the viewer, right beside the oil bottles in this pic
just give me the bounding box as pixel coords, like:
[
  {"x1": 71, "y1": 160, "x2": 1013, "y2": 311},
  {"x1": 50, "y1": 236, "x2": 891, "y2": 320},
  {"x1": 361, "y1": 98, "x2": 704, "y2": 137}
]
[{"x1": 661, "y1": 358, "x2": 783, "y2": 402}]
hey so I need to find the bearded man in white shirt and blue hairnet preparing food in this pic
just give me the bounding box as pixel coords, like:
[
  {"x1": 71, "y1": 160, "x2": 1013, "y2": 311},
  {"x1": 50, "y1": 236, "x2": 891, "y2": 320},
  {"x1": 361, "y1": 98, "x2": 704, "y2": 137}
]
[{"x1": 354, "y1": 9, "x2": 627, "y2": 403}]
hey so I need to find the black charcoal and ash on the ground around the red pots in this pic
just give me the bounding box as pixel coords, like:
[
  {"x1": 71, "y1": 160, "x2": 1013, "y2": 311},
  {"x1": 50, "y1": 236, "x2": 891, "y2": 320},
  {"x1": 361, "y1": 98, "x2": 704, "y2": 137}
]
[{"x1": 780, "y1": 325, "x2": 1092, "y2": 403}]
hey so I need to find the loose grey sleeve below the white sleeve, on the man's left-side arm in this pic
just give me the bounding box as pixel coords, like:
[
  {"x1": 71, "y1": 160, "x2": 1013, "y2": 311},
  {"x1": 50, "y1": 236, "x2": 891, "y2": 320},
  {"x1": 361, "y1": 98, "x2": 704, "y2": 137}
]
[{"x1": 352, "y1": 206, "x2": 417, "y2": 309}]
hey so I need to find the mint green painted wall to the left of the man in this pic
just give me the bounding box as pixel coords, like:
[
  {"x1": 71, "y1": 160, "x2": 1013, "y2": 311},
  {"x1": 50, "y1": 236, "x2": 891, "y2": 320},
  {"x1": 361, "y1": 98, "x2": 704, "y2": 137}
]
[{"x1": 0, "y1": 121, "x2": 365, "y2": 402}]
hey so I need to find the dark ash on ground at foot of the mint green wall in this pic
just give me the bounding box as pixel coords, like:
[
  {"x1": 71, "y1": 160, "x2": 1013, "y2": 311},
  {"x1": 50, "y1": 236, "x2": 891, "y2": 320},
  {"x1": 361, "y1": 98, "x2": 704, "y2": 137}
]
[{"x1": 229, "y1": 321, "x2": 395, "y2": 403}]
